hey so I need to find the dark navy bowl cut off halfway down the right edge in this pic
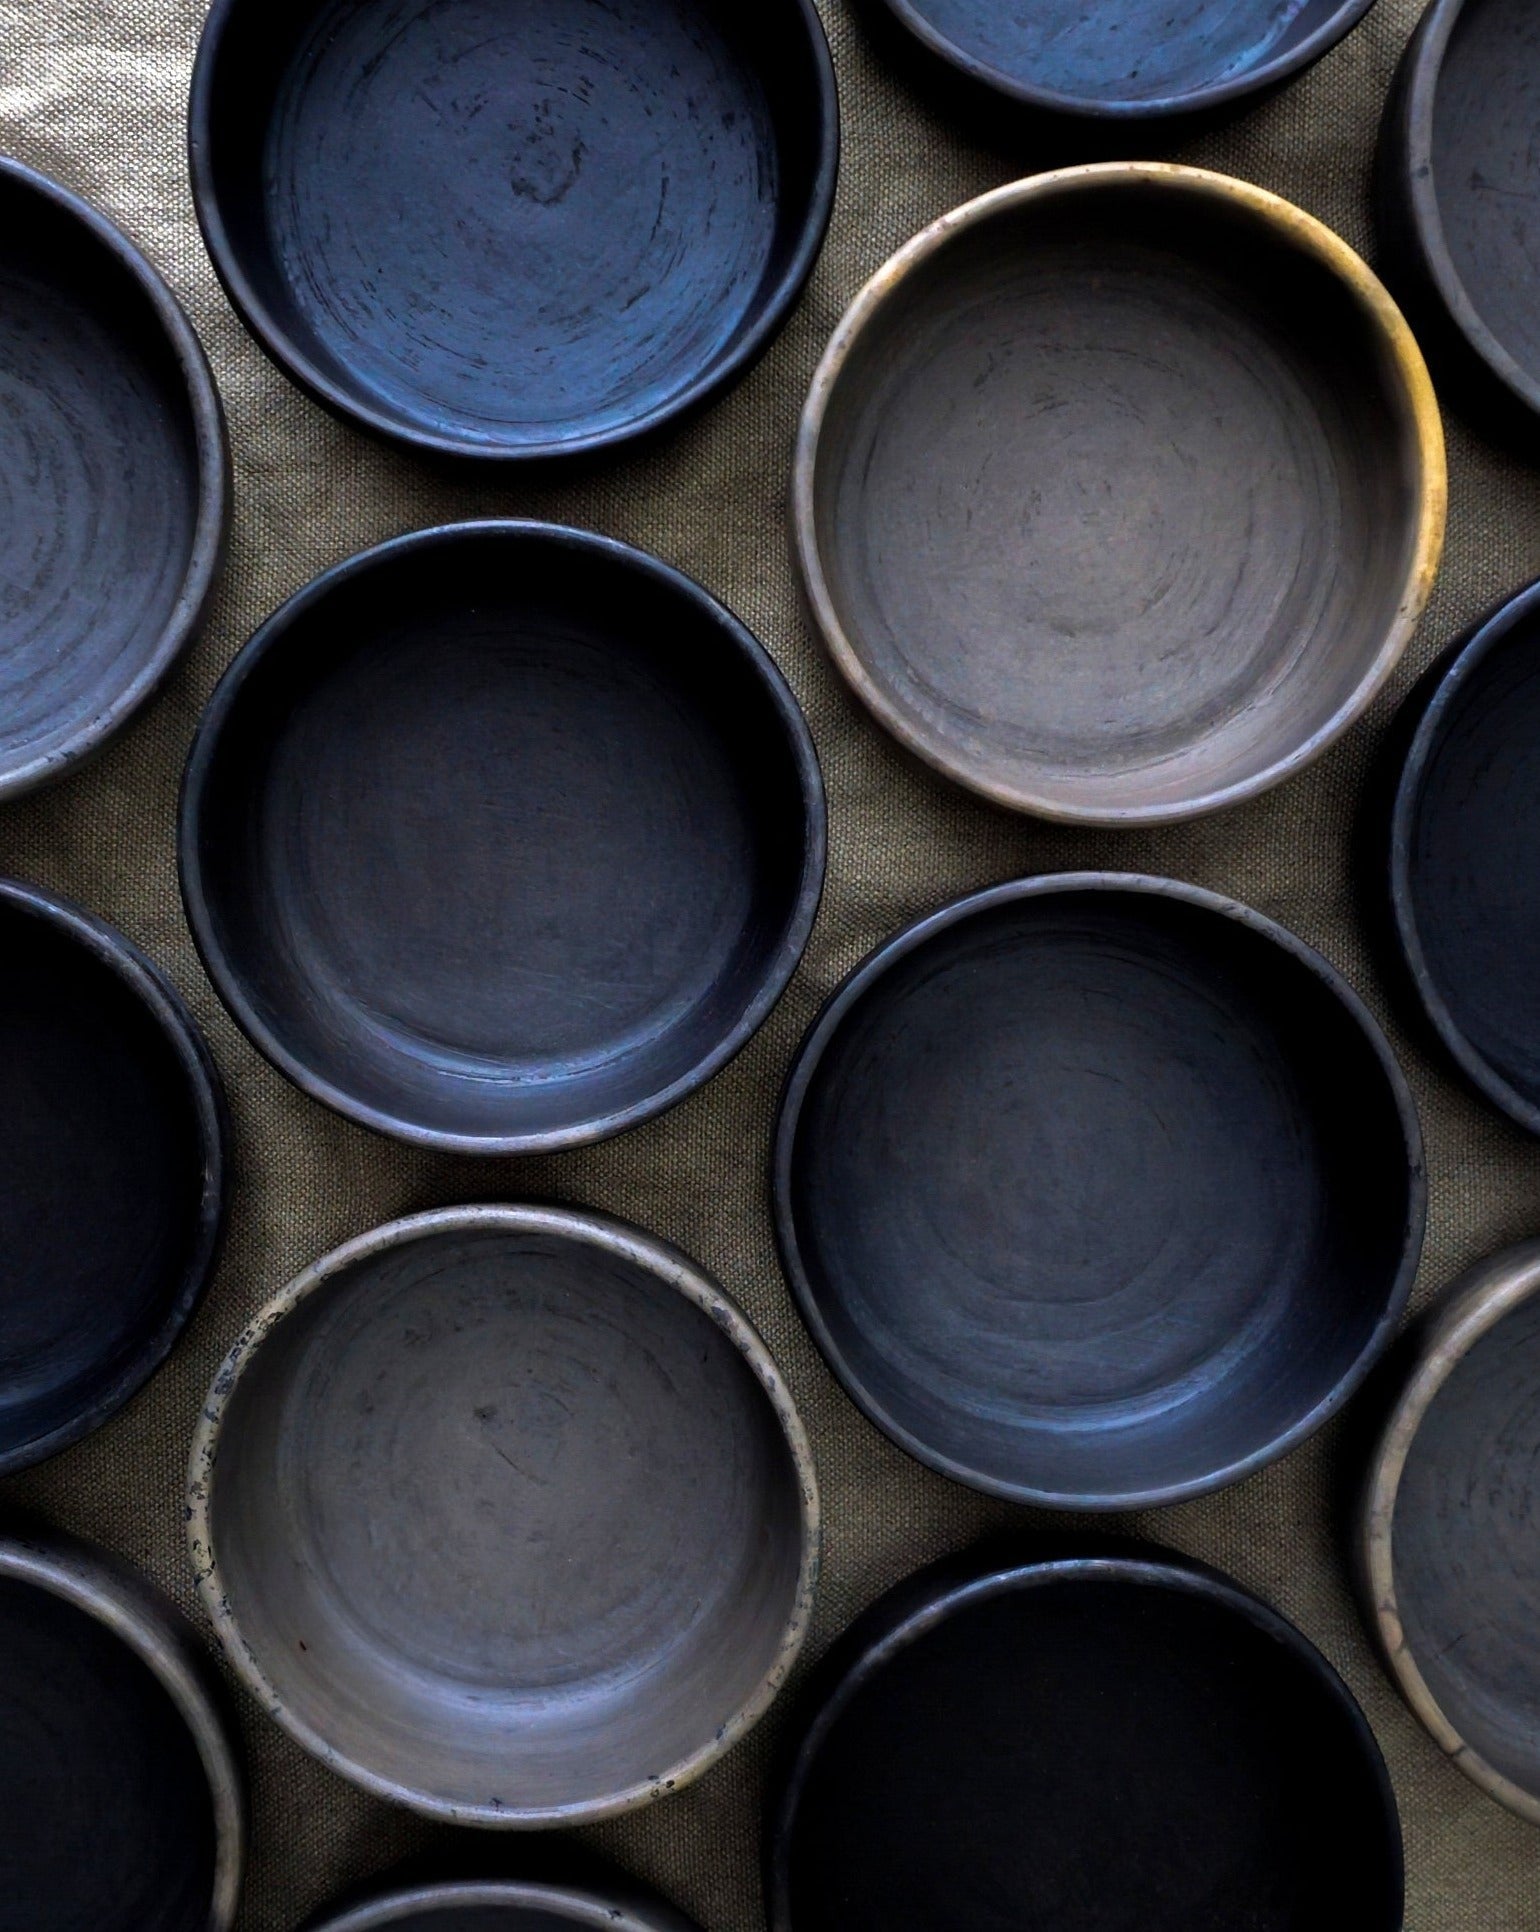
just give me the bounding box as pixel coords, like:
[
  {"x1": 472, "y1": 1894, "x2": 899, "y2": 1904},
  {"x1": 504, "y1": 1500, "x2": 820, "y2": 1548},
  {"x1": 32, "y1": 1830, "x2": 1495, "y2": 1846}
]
[{"x1": 1389, "y1": 585, "x2": 1540, "y2": 1134}]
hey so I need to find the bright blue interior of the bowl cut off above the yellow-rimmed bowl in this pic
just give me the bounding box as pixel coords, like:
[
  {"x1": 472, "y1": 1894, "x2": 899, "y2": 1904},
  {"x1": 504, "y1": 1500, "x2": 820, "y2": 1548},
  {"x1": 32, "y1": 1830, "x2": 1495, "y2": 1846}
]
[{"x1": 898, "y1": 0, "x2": 1355, "y2": 110}]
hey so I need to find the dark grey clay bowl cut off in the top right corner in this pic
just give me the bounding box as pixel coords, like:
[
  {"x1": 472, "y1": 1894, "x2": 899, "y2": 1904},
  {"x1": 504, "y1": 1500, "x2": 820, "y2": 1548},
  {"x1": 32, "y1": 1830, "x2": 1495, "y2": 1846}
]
[{"x1": 1378, "y1": 0, "x2": 1540, "y2": 435}]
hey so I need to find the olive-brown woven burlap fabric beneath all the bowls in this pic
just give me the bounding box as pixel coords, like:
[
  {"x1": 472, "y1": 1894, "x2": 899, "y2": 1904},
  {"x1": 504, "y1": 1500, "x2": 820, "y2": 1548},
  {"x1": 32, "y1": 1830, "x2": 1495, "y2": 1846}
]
[{"x1": 0, "y1": 0, "x2": 1540, "y2": 1932}]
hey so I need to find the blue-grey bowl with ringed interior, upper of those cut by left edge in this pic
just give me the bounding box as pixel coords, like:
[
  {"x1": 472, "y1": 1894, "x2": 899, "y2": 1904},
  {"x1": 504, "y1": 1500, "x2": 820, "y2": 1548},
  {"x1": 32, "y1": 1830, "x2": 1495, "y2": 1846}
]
[{"x1": 0, "y1": 156, "x2": 228, "y2": 798}]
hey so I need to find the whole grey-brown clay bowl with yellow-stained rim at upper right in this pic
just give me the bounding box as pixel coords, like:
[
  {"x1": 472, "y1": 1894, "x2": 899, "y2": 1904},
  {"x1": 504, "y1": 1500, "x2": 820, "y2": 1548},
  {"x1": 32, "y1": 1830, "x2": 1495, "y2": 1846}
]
[{"x1": 794, "y1": 162, "x2": 1445, "y2": 825}]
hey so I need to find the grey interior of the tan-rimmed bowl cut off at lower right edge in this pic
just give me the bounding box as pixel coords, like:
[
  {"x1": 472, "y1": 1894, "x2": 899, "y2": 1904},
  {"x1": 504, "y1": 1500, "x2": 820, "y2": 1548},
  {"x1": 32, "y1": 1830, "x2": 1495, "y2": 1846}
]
[{"x1": 1391, "y1": 1298, "x2": 1540, "y2": 1799}]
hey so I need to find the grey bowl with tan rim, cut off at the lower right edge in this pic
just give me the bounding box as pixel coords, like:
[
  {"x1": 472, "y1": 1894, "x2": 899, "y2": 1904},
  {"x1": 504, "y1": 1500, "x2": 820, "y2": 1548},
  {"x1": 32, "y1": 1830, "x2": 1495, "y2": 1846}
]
[{"x1": 1358, "y1": 1242, "x2": 1540, "y2": 1824}]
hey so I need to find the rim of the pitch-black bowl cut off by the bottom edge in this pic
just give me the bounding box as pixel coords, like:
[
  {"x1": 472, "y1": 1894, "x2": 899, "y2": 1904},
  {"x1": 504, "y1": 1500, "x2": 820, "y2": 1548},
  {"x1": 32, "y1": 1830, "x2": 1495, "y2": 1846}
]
[{"x1": 765, "y1": 1538, "x2": 1405, "y2": 1932}]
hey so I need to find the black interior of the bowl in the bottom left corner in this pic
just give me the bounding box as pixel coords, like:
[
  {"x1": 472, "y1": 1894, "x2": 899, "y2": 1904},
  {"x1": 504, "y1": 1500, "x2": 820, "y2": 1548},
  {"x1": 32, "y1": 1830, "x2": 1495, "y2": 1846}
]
[{"x1": 0, "y1": 1577, "x2": 216, "y2": 1932}]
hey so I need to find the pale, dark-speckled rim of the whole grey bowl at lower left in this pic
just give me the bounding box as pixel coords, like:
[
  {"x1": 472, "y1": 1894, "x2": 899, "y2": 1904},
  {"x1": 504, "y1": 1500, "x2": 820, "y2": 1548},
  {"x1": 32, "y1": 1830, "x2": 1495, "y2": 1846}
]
[{"x1": 185, "y1": 1206, "x2": 821, "y2": 1832}]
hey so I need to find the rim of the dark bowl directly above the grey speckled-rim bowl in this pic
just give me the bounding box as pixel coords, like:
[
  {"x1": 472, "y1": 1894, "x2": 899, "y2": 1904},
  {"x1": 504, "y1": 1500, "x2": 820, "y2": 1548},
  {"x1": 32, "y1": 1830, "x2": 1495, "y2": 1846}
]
[{"x1": 176, "y1": 518, "x2": 829, "y2": 1155}]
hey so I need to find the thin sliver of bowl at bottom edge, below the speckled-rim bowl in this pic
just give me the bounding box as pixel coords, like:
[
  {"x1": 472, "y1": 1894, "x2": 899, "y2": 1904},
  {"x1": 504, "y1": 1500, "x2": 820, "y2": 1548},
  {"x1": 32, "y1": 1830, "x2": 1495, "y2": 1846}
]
[{"x1": 309, "y1": 1880, "x2": 696, "y2": 1932}]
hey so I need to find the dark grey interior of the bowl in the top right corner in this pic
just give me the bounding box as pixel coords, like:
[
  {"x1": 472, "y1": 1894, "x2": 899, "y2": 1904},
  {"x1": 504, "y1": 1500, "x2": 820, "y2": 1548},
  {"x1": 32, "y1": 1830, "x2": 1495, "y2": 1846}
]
[{"x1": 1432, "y1": 0, "x2": 1540, "y2": 383}]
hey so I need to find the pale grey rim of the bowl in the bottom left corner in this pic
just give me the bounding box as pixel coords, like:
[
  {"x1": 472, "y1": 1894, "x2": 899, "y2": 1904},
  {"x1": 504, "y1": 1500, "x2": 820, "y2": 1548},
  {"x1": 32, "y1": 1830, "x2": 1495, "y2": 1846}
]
[{"x1": 0, "y1": 1528, "x2": 247, "y2": 1932}]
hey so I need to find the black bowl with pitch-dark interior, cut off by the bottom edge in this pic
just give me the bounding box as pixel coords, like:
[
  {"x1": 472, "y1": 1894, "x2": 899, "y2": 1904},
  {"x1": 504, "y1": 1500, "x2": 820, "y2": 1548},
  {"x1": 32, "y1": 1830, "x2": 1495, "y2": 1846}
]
[{"x1": 767, "y1": 1546, "x2": 1403, "y2": 1932}]
